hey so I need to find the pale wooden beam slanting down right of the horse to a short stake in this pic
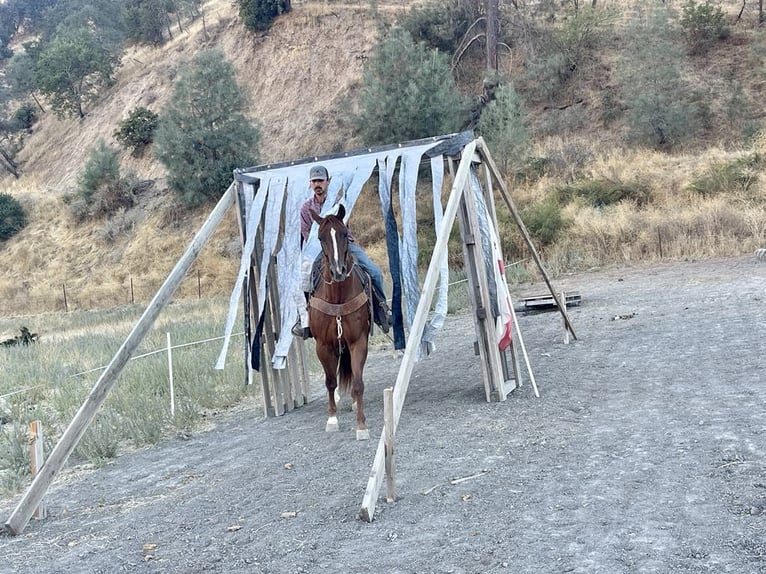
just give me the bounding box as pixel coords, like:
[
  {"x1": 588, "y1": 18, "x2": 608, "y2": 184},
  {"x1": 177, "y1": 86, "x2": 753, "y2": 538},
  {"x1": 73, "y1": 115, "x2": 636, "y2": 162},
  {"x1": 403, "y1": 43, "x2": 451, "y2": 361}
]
[{"x1": 360, "y1": 140, "x2": 476, "y2": 522}]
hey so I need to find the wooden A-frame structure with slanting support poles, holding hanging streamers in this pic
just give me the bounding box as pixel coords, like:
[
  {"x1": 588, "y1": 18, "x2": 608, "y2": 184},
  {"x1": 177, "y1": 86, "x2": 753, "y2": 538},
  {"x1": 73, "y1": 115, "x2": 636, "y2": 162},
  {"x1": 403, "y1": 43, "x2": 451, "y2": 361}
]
[{"x1": 5, "y1": 132, "x2": 576, "y2": 535}]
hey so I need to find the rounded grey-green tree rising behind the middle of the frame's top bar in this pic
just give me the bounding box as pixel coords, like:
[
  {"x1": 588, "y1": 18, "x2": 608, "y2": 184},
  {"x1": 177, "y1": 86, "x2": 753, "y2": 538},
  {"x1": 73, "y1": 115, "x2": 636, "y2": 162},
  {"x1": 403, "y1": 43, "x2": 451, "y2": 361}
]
[{"x1": 354, "y1": 28, "x2": 468, "y2": 145}]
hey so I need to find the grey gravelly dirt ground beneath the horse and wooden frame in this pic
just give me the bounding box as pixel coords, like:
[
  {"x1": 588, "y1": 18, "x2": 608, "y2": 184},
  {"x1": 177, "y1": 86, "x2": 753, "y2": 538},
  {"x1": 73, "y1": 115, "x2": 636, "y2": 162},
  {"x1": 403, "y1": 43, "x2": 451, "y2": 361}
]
[{"x1": 0, "y1": 257, "x2": 766, "y2": 574}]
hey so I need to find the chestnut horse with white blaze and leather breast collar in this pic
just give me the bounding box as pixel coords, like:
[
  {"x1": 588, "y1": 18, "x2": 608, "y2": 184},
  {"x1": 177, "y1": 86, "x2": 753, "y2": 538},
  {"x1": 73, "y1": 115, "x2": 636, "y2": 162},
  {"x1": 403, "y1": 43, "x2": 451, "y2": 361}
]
[{"x1": 309, "y1": 205, "x2": 372, "y2": 440}]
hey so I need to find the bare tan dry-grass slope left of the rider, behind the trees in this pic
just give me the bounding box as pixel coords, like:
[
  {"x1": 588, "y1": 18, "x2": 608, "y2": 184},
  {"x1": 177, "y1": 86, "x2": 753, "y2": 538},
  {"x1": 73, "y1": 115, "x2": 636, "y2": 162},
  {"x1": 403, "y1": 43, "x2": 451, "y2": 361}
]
[{"x1": 0, "y1": 0, "x2": 399, "y2": 312}]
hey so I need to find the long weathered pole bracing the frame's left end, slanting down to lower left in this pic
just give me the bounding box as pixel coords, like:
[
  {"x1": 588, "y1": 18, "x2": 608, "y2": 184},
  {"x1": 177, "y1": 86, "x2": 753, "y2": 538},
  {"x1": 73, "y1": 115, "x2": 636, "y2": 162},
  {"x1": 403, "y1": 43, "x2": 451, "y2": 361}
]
[{"x1": 5, "y1": 183, "x2": 234, "y2": 536}]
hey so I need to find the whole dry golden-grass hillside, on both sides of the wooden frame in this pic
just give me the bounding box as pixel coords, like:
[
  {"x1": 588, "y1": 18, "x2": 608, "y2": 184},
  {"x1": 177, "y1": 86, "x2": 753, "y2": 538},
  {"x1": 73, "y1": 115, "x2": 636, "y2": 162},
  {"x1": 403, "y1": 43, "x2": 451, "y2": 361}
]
[{"x1": 0, "y1": 0, "x2": 766, "y2": 314}]
